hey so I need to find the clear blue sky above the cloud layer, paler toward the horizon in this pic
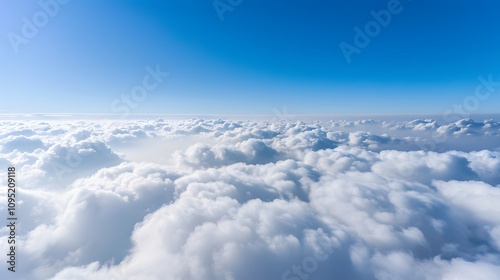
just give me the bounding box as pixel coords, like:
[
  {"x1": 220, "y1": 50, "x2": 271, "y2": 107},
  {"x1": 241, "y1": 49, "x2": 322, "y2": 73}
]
[{"x1": 0, "y1": 0, "x2": 500, "y2": 114}]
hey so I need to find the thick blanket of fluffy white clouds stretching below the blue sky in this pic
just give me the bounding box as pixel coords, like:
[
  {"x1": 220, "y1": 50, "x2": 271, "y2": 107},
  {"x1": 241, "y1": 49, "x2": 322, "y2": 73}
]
[{"x1": 0, "y1": 119, "x2": 500, "y2": 280}]
